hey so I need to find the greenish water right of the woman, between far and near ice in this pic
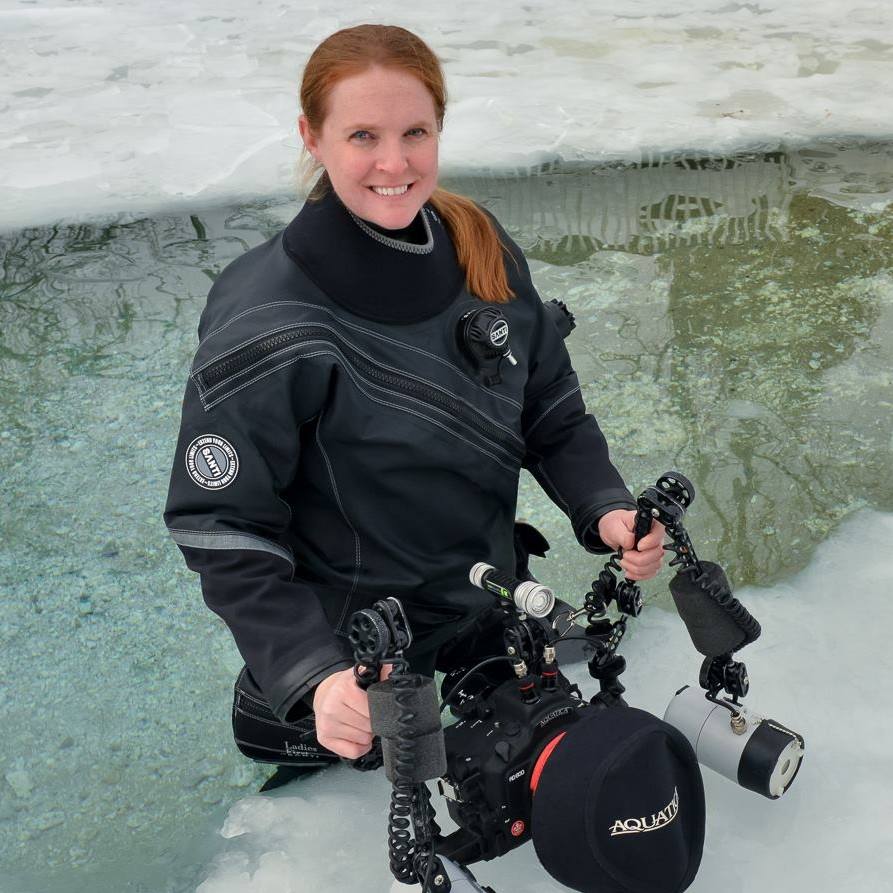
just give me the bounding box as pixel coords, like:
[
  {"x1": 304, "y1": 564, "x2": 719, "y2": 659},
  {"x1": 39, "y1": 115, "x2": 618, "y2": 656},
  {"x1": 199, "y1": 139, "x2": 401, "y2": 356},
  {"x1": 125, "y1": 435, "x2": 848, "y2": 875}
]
[{"x1": 450, "y1": 144, "x2": 893, "y2": 583}]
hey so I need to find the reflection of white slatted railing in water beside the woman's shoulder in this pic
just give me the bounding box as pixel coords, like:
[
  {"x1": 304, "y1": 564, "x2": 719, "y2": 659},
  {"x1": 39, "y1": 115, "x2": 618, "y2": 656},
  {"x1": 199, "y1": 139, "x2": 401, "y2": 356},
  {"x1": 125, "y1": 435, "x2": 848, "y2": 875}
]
[{"x1": 457, "y1": 152, "x2": 791, "y2": 263}]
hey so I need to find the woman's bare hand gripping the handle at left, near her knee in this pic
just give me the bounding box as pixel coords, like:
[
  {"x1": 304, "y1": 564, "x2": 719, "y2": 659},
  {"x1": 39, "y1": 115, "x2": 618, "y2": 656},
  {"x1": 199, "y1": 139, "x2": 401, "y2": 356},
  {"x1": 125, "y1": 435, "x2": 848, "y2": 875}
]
[{"x1": 313, "y1": 667, "x2": 378, "y2": 760}]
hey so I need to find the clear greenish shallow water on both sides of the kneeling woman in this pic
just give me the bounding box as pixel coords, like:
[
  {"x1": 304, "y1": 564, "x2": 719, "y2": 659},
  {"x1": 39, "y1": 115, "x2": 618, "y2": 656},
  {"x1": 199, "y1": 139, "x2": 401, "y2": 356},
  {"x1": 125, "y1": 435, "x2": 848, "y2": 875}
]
[{"x1": 0, "y1": 144, "x2": 893, "y2": 893}]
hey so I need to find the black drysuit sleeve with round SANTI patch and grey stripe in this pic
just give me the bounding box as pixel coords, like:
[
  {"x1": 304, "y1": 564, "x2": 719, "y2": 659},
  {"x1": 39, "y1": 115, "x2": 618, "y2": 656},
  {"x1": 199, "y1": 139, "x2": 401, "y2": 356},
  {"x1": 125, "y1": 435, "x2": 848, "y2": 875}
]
[{"x1": 164, "y1": 318, "x2": 352, "y2": 720}]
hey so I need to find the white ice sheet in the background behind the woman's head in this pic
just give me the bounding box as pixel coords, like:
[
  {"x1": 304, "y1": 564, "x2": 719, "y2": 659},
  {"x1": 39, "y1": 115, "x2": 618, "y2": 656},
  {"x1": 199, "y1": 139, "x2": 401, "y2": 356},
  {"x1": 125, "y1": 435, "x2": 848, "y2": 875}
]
[{"x1": 0, "y1": 0, "x2": 893, "y2": 229}]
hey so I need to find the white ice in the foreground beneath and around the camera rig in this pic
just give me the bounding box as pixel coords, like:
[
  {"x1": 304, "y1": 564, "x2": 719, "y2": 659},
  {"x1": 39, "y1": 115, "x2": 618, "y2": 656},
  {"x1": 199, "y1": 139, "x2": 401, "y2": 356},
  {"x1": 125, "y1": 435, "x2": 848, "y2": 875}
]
[{"x1": 197, "y1": 511, "x2": 893, "y2": 893}]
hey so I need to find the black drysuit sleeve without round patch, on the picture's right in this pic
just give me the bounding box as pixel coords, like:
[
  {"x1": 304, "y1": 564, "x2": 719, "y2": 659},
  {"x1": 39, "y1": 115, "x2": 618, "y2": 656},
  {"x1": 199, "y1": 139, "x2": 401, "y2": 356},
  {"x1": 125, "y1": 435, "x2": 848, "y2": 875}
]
[{"x1": 518, "y1": 250, "x2": 636, "y2": 552}]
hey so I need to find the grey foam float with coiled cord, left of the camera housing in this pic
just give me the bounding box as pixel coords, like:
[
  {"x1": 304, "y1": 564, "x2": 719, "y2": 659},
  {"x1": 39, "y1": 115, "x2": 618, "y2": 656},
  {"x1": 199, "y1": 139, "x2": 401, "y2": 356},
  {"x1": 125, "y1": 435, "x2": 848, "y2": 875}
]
[{"x1": 368, "y1": 673, "x2": 446, "y2": 783}]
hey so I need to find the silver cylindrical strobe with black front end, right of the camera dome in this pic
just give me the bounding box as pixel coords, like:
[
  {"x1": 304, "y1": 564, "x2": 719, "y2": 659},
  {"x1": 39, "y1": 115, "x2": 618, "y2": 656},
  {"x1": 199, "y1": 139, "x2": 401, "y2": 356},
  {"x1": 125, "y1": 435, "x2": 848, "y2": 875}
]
[{"x1": 664, "y1": 686, "x2": 804, "y2": 800}]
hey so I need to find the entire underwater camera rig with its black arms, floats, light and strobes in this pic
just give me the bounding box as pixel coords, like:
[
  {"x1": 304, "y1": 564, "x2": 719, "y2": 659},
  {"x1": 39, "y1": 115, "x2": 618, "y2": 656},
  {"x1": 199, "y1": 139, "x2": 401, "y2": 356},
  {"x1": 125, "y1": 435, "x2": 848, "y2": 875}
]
[{"x1": 351, "y1": 472, "x2": 804, "y2": 893}]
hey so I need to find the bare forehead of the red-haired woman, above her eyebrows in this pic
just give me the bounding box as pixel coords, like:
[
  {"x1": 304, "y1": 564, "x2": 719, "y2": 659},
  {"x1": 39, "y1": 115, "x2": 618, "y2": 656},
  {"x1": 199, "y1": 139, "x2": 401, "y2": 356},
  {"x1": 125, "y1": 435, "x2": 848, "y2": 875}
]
[{"x1": 326, "y1": 66, "x2": 436, "y2": 128}]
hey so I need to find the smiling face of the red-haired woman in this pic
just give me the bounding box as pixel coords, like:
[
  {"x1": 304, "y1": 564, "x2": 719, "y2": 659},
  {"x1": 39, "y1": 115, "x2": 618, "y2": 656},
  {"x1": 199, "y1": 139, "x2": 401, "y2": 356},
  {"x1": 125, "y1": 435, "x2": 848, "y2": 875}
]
[{"x1": 298, "y1": 66, "x2": 438, "y2": 229}]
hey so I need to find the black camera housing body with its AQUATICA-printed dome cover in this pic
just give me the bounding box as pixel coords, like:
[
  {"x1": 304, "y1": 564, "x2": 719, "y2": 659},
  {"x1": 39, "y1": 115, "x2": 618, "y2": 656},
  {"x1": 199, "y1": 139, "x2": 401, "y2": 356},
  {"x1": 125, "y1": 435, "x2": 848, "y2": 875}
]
[{"x1": 436, "y1": 664, "x2": 705, "y2": 893}]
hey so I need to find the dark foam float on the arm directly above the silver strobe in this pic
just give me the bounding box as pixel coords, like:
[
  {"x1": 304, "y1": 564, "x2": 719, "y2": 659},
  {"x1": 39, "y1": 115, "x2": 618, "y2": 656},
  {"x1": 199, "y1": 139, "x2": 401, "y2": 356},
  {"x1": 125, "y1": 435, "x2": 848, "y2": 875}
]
[{"x1": 670, "y1": 561, "x2": 760, "y2": 657}]
